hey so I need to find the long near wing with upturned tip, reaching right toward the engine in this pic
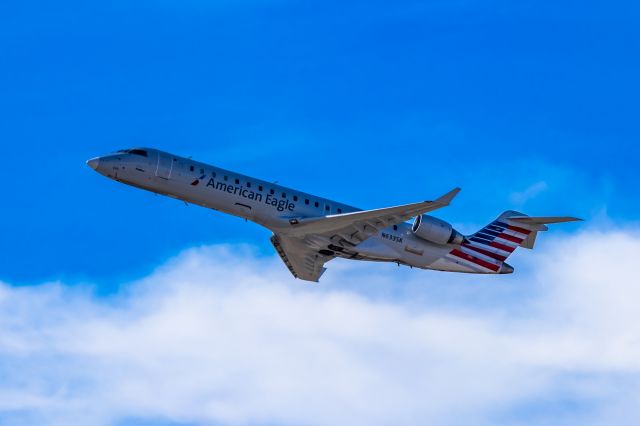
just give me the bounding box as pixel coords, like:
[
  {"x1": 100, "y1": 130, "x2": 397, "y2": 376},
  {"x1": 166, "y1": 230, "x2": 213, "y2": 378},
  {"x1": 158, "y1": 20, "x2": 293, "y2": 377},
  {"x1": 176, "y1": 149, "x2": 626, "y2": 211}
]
[{"x1": 286, "y1": 188, "x2": 460, "y2": 245}]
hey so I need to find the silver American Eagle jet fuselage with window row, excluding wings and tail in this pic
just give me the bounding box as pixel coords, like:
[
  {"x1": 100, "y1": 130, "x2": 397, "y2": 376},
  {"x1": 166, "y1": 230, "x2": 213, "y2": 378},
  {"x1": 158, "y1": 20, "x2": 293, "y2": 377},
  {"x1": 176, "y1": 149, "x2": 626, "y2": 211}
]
[{"x1": 88, "y1": 148, "x2": 478, "y2": 273}]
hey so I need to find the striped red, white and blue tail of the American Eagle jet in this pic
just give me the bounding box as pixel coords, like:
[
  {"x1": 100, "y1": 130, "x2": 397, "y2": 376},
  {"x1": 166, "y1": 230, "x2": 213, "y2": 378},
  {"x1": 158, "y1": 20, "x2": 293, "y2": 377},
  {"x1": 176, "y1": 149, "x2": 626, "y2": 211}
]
[{"x1": 450, "y1": 210, "x2": 582, "y2": 274}]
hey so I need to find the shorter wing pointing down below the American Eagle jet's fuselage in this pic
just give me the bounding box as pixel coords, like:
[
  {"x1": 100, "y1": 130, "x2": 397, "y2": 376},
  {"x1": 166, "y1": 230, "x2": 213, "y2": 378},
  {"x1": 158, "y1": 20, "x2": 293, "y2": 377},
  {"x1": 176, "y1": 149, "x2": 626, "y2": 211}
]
[{"x1": 271, "y1": 234, "x2": 336, "y2": 282}]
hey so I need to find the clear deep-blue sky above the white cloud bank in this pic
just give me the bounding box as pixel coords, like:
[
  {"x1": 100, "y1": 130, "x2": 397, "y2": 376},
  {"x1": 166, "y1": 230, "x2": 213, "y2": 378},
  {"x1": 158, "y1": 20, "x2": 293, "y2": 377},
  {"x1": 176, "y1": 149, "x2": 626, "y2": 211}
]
[{"x1": 0, "y1": 0, "x2": 640, "y2": 284}]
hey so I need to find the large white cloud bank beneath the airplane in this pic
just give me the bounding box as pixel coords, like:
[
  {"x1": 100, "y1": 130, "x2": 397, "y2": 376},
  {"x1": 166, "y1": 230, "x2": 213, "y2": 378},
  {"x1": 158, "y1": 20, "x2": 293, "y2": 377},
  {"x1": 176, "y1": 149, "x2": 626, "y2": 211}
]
[{"x1": 0, "y1": 232, "x2": 640, "y2": 425}]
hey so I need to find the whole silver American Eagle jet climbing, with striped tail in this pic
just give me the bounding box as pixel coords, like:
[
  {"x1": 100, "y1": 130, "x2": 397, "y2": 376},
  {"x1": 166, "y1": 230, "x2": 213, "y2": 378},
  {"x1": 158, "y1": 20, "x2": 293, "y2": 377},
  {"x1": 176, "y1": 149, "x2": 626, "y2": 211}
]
[{"x1": 87, "y1": 148, "x2": 581, "y2": 282}]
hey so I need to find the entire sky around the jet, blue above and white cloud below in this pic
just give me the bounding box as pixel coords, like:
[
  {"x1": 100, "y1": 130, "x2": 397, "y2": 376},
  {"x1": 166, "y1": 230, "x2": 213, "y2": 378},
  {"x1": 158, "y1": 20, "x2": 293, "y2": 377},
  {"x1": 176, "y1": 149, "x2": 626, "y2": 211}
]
[{"x1": 0, "y1": 0, "x2": 640, "y2": 425}]
